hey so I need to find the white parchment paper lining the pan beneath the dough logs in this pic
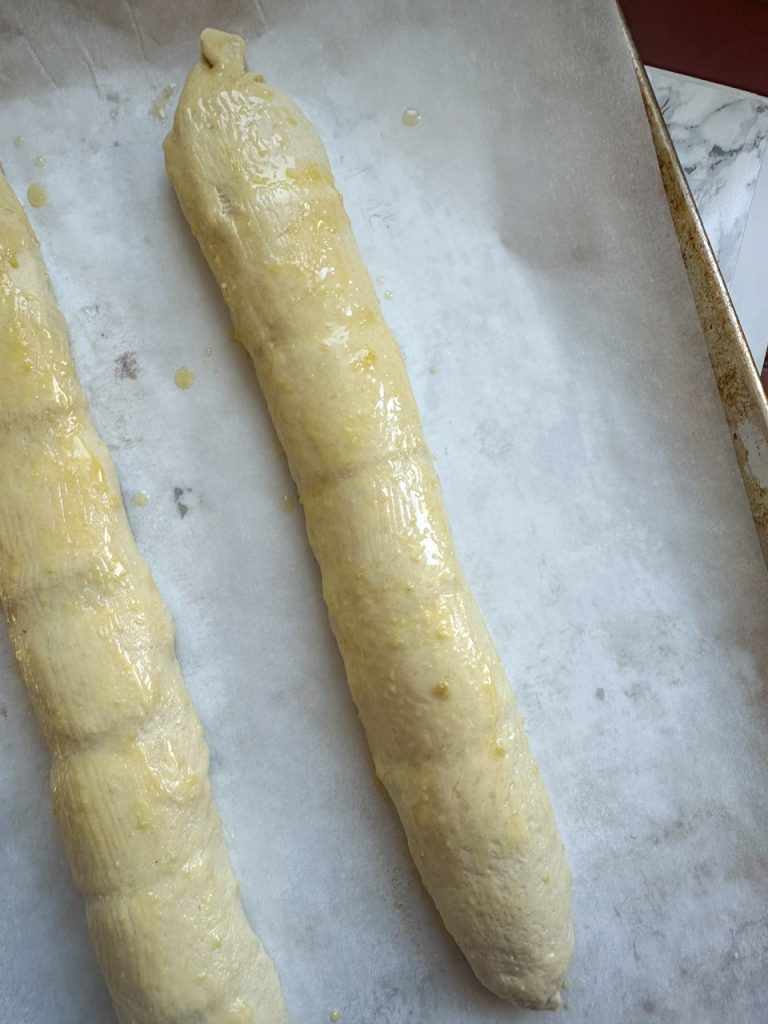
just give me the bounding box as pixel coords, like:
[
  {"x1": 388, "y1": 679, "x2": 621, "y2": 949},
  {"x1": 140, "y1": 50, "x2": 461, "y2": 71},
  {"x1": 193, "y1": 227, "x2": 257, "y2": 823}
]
[{"x1": 0, "y1": 0, "x2": 768, "y2": 1024}]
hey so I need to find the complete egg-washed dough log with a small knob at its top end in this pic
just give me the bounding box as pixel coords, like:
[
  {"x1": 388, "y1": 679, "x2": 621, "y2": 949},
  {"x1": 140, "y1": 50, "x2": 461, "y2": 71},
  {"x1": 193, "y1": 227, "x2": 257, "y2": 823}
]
[{"x1": 165, "y1": 29, "x2": 572, "y2": 1008}]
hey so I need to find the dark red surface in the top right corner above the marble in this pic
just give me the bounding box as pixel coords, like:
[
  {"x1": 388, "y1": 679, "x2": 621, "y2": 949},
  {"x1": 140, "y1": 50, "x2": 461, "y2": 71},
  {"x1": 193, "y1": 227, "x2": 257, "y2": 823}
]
[{"x1": 620, "y1": 0, "x2": 768, "y2": 96}]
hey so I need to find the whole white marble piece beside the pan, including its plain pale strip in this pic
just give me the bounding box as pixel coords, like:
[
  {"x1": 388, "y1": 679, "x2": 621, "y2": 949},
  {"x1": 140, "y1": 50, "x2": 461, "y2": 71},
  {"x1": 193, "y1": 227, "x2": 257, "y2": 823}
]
[{"x1": 647, "y1": 68, "x2": 768, "y2": 369}]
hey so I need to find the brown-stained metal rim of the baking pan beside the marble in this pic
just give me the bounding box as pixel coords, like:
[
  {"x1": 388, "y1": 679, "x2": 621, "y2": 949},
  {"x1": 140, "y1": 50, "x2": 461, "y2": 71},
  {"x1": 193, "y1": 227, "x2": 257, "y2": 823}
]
[{"x1": 625, "y1": 9, "x2": 768, "y2": 563}]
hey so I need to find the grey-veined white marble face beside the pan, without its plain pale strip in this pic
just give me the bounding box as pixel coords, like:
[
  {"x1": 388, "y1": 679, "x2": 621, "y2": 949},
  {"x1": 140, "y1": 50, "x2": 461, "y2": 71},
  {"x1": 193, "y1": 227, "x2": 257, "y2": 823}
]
[{"x1": 648, "y1": 68, "x2": 768, "y2": 284}]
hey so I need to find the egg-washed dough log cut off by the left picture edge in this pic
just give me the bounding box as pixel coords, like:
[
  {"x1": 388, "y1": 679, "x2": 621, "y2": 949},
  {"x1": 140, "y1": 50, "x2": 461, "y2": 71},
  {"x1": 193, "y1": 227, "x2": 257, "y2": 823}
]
[{"x1": 0, "y1": 174, "x2": 288, "y2": 1024}]
